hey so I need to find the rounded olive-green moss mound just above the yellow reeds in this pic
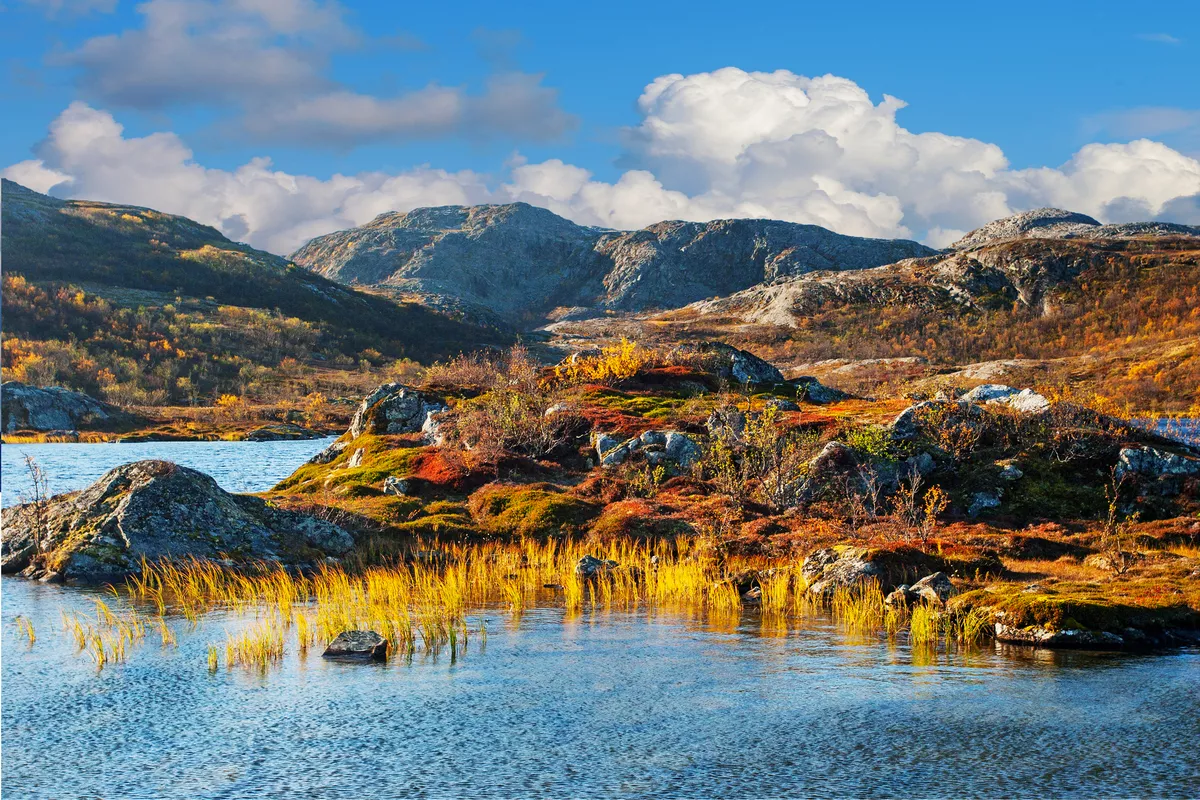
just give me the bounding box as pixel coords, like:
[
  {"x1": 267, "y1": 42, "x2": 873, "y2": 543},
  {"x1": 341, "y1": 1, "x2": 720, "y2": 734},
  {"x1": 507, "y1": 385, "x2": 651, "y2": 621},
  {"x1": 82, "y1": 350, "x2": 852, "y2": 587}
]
[{"x1": 469, "y1": 483, "x2": 596, "y2": 536}]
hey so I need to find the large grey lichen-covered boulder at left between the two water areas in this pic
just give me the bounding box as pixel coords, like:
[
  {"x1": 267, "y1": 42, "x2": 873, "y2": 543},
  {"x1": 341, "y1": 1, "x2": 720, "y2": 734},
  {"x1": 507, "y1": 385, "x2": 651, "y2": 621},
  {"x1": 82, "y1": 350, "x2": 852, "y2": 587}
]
[{"x1": 0, "y1": 461, "x2": 354, "y2": 583}]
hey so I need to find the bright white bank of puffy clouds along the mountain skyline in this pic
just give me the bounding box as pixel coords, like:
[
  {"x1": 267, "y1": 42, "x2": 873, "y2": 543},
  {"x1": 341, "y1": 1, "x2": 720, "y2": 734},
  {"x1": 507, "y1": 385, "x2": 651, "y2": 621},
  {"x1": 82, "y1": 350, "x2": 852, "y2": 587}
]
[{"x1": 5, "y1": 68, "x2": 1200, "y2": 253}]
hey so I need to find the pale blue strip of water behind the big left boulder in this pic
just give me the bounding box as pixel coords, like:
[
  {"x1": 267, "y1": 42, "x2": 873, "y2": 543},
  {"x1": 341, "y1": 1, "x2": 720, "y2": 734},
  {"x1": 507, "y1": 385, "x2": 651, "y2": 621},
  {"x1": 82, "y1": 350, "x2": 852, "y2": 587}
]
[{"x1": 0, "y1": 439, "x2": 332, "y2": 506}]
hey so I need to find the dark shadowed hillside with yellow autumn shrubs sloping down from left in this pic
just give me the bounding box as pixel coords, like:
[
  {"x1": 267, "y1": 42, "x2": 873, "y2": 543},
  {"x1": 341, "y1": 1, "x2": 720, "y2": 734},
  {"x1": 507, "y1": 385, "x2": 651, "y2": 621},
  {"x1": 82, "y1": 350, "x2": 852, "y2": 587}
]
[{"x1": 0, "y1": 180, "x2": 505, "y2": 404}]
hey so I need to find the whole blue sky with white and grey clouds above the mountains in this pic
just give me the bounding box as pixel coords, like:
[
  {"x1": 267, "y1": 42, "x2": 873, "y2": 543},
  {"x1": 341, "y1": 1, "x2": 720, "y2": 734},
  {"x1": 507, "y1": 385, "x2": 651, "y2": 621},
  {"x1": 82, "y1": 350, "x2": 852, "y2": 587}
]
[{"x1": 0, "y1": 0, "x2": 1200, "y2": 254}]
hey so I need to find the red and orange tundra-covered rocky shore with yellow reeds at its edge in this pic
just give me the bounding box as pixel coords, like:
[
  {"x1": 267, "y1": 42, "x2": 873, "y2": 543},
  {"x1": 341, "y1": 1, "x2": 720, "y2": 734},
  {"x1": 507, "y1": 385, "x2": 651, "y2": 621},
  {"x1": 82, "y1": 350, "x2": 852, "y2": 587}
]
[{"x1": 11, "y1": 341, "x2": 1200, "y2": 668}]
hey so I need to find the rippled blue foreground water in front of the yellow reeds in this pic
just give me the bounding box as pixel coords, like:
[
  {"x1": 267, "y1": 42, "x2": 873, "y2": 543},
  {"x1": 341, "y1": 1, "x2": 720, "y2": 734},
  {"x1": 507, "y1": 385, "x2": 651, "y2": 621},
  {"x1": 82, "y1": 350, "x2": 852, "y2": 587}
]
[{"x1": 0, "y1": 578, "x2": 1200, "y2": 800}]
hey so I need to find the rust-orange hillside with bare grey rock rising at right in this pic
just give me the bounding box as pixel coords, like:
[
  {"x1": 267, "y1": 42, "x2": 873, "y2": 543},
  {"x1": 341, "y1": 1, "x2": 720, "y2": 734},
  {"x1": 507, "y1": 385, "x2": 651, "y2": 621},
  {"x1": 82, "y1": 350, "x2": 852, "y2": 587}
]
[{"x1": 551, "y1": 211, "x2": 1200, "y2": 411}]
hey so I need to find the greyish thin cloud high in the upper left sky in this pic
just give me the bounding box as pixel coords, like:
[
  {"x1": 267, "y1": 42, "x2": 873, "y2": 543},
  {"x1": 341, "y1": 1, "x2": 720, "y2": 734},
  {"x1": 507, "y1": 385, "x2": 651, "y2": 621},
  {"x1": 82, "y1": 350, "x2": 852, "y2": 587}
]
[{"x1": 55, "y1": 0, "x2": 575, "y2": 148}]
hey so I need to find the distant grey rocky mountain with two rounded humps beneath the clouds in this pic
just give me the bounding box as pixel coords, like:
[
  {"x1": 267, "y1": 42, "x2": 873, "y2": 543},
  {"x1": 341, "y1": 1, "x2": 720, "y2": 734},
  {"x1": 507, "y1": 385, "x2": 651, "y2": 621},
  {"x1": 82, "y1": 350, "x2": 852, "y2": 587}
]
[{"x1": 292, "y1": 203, "x2": 936, "y2": 320}]
